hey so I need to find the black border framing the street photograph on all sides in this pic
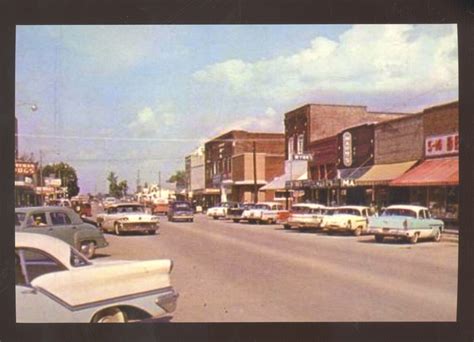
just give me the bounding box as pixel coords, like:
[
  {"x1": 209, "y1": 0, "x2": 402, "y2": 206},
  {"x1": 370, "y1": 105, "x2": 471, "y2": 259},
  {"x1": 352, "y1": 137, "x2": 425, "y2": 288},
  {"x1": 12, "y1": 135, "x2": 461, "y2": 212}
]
[{"x1": 0, "y1": 0, "x2": 474, "y2": 342}]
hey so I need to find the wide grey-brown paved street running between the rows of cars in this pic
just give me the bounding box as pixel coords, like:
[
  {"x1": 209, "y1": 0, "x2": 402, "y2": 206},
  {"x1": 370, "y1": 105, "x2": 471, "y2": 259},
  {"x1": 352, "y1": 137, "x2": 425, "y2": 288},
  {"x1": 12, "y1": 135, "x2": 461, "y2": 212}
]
[{"x1": 93, "y1": 207, "x2": 458, "y2": 322}]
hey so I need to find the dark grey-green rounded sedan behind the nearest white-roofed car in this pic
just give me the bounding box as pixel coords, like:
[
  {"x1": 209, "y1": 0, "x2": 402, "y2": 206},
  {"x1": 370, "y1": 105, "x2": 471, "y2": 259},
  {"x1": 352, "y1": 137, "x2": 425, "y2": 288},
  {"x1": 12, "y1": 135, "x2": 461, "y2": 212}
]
[{"x1": 15, "y1": 207, "x2": 108, "y2": 258}]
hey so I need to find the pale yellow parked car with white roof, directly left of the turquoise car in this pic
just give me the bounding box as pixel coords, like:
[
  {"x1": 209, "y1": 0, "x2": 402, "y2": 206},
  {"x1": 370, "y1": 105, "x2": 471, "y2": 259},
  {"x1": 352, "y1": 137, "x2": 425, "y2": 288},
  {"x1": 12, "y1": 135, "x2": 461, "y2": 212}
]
[{"x1": 321, "y1": 205, "x2": 370, "y2": 236}]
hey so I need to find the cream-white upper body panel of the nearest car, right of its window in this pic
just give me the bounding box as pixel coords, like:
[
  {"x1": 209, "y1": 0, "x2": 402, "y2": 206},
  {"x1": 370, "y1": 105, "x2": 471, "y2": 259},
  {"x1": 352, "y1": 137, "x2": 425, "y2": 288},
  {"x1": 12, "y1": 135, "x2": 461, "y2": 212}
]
[{"x1": 31, "y1": 259, "x2": 172, "y2": 306}]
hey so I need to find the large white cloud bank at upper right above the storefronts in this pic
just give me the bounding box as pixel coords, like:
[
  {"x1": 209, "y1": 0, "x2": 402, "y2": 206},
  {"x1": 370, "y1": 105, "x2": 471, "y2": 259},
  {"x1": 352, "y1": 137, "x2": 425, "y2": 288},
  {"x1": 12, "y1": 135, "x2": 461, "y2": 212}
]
[{"x1": 193, "y1": 25, "x2": 458, "y2": 103}]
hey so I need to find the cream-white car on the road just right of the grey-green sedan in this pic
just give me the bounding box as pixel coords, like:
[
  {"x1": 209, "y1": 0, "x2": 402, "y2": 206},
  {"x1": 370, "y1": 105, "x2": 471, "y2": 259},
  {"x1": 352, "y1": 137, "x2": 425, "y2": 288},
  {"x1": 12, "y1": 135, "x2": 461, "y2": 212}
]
[{"x1": 97, "y1": 203, "x2": 160, "y2": 235}]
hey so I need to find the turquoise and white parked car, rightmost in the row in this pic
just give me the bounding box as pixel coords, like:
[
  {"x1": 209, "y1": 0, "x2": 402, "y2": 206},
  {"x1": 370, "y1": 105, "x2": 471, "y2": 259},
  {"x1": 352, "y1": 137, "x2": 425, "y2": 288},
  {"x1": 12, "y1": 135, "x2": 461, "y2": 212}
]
[{"x1": 368, "y1": 205, "x2": 444, "y2": 243}]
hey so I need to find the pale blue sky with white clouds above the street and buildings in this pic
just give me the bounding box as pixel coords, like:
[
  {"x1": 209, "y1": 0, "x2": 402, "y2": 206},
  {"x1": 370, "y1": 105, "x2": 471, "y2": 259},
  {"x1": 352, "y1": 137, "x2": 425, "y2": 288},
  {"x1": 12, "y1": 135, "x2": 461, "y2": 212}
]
[{"x1": 15, "y1": 24, "x2": 458, "y2": 193}]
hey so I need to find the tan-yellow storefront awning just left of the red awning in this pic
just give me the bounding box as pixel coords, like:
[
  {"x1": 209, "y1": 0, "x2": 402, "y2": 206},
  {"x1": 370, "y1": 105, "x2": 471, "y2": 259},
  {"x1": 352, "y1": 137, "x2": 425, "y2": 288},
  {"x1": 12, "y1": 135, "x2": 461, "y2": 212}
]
[{"x1": 355, "y1": 160, "x2": 417, "y2": 186}]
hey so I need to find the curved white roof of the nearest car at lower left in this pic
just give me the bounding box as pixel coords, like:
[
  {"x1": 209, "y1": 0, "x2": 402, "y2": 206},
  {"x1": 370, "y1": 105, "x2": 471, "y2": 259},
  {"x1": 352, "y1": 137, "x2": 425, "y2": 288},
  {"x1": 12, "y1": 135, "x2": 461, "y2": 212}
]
[{"x1": 15, "y1": 233, "x2": 71, "y2": 268}]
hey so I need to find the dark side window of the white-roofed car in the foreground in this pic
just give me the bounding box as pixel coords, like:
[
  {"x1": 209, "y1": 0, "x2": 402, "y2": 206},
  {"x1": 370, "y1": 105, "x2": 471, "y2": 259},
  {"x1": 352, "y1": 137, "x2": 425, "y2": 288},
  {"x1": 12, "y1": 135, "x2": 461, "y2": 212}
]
[{"x1": 18, "y1": 249, "x2": 67, "y2": 283}]
